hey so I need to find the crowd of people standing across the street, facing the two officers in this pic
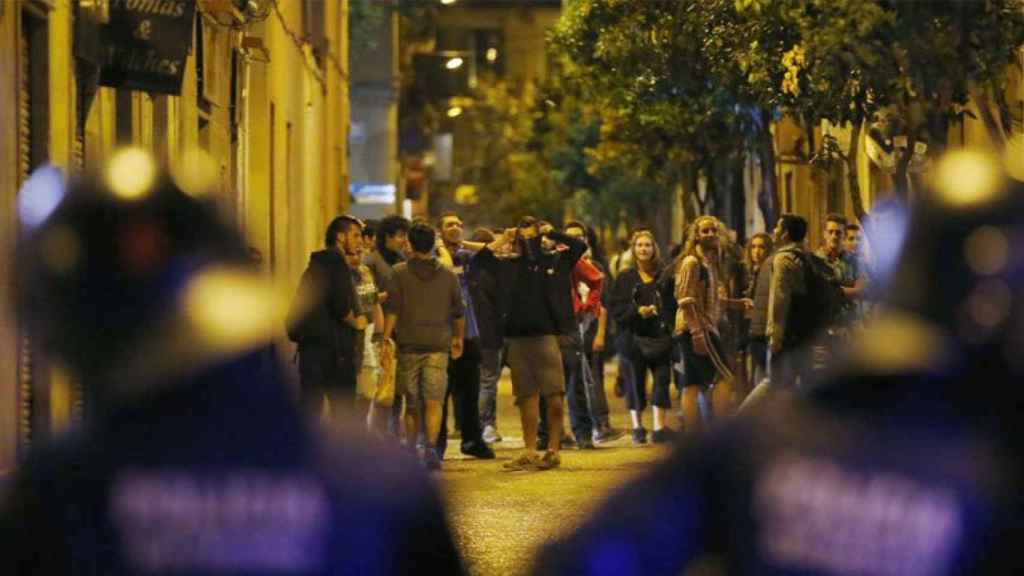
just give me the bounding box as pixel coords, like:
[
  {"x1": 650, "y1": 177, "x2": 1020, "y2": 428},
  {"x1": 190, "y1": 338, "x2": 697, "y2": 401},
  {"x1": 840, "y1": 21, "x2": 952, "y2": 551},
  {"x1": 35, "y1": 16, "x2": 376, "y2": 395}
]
[{"x1": 289, "y1": 201, "x2": 869, "y2": 470}]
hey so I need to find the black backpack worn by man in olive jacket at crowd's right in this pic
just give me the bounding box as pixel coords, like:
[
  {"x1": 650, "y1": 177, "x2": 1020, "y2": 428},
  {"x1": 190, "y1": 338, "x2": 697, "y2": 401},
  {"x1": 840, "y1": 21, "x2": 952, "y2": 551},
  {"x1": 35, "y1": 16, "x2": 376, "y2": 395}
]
[{"x1": 785, "y1": 250, "x2": 848, "y2": 347}]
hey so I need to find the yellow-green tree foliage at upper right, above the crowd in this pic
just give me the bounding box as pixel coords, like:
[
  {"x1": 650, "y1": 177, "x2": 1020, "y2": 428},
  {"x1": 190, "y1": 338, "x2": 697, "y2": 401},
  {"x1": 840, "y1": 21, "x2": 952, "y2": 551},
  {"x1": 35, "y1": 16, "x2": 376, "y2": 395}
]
[{"x1": 554, "y1": 0, "x2": 1024, "y2": 222}]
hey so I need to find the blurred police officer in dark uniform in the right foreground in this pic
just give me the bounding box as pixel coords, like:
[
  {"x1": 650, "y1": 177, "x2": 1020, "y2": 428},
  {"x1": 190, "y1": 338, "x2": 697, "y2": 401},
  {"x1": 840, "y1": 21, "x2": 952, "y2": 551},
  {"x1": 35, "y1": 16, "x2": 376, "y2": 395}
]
[{"x1": 536, "y1": 148, "x2": 1024, "y2": 576}]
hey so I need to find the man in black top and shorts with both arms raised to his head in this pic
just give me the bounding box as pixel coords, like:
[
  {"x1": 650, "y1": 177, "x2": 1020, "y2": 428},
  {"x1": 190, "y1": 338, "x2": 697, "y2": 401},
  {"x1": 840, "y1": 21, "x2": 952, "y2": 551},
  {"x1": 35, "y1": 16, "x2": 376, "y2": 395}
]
[{"x1": 474, "y1": 217, "x2": 587, "y2": 470}]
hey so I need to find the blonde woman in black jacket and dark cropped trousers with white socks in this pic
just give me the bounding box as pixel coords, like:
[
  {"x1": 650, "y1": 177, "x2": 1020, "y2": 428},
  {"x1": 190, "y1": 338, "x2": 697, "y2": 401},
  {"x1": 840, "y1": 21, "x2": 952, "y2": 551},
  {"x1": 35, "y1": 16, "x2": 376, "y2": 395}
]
[{"x1": 611, "y1": 230, "x2": 675, "y2": 444}]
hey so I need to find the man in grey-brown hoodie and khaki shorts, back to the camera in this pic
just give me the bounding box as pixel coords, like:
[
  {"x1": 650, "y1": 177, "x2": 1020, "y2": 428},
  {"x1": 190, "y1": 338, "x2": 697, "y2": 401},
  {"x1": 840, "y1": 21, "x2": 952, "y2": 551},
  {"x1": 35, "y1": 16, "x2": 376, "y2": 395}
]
[{"x1": 384, "y1": 222, "x2": 466, "y2": 469}]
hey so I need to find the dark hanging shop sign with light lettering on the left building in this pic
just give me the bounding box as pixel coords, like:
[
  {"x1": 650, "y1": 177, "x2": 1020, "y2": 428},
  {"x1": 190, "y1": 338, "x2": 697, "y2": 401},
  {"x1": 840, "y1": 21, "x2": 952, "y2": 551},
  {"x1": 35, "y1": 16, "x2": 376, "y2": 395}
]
[{"x1": 99, "y1": 0, "x2": 196, "y2": 94}]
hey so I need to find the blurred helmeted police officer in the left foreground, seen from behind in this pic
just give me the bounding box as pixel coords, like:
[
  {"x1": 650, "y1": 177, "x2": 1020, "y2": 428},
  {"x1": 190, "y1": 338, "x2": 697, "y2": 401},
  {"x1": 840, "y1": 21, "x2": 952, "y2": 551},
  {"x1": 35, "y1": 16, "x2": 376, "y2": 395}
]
[{"x1": 0, "y1": 153, "x2": 463, "y2": 575}]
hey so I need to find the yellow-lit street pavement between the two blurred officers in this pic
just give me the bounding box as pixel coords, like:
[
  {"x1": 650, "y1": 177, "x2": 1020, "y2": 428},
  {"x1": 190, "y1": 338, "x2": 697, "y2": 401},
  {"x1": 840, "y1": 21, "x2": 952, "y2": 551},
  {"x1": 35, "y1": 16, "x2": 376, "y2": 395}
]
[{"x1": 439, "y1": 371, "x2": 668, "y2": 576}]
